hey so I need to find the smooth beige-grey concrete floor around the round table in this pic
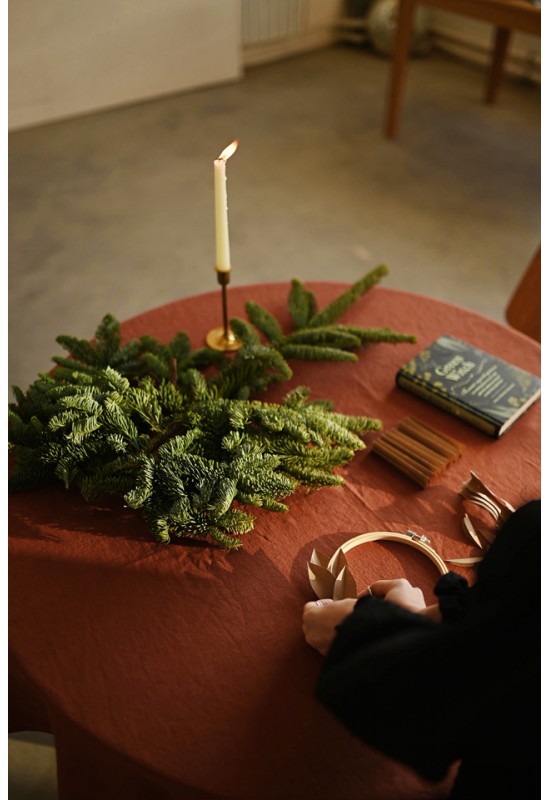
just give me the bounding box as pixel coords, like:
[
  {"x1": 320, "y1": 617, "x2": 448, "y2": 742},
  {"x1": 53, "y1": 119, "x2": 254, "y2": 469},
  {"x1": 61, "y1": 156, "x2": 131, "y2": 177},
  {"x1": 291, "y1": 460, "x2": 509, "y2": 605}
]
[{"x1": 8, "y1": 46, "x2": 541, "y2": 800}]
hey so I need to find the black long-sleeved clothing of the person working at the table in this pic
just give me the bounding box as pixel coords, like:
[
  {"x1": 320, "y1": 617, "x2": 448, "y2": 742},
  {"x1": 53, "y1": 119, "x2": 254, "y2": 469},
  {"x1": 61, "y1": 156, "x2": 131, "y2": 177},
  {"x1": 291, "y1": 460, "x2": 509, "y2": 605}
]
[{"x1": 317, "y1": 508, "x2": 540, "y2": 780}]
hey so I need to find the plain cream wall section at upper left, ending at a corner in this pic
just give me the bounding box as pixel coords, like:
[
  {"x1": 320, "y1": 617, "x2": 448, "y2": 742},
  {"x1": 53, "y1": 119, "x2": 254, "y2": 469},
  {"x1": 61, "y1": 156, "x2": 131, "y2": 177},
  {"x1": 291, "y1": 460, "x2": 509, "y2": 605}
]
[{"x1": 8, "y1": 0, "x2": 241, "y2": 129}]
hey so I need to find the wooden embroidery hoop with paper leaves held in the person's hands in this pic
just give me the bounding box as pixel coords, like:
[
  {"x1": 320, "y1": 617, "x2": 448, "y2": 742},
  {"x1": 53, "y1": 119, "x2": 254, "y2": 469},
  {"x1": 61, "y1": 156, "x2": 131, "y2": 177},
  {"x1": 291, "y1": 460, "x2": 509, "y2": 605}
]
[{"x1": 307, "y1": 530, "x2": 449, "y2": 600}]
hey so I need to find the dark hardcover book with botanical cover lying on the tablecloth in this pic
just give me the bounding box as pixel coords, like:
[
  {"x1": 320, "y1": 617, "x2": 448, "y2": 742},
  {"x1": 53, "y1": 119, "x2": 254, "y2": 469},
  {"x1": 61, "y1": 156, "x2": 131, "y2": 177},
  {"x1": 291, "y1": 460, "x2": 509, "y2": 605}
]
[{"x1": 396, "y1": 334, "x2": 541, "y2": 436}]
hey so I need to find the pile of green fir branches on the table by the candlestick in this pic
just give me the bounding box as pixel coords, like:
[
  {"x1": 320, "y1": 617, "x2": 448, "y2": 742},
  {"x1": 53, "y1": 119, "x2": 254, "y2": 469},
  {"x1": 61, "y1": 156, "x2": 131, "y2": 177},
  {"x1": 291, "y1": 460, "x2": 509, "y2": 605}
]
[{"x1": 9, "y1": 266, "x2": 415, "y2": 548}]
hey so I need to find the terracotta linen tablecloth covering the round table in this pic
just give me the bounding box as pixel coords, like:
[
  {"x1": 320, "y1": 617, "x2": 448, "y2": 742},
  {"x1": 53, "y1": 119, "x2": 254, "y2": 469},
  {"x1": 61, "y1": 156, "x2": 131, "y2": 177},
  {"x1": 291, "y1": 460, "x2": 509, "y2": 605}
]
[{"x1": 9, "y1": 283, "x2": 540, "y2": 800}]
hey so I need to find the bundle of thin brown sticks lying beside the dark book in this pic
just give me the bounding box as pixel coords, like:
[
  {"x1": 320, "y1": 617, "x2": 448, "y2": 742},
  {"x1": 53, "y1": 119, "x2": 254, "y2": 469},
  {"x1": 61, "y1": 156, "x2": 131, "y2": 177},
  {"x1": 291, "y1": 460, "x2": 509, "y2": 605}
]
[{"x1": 372, "y1": 417, "x2": 463, "y2": 487}]
